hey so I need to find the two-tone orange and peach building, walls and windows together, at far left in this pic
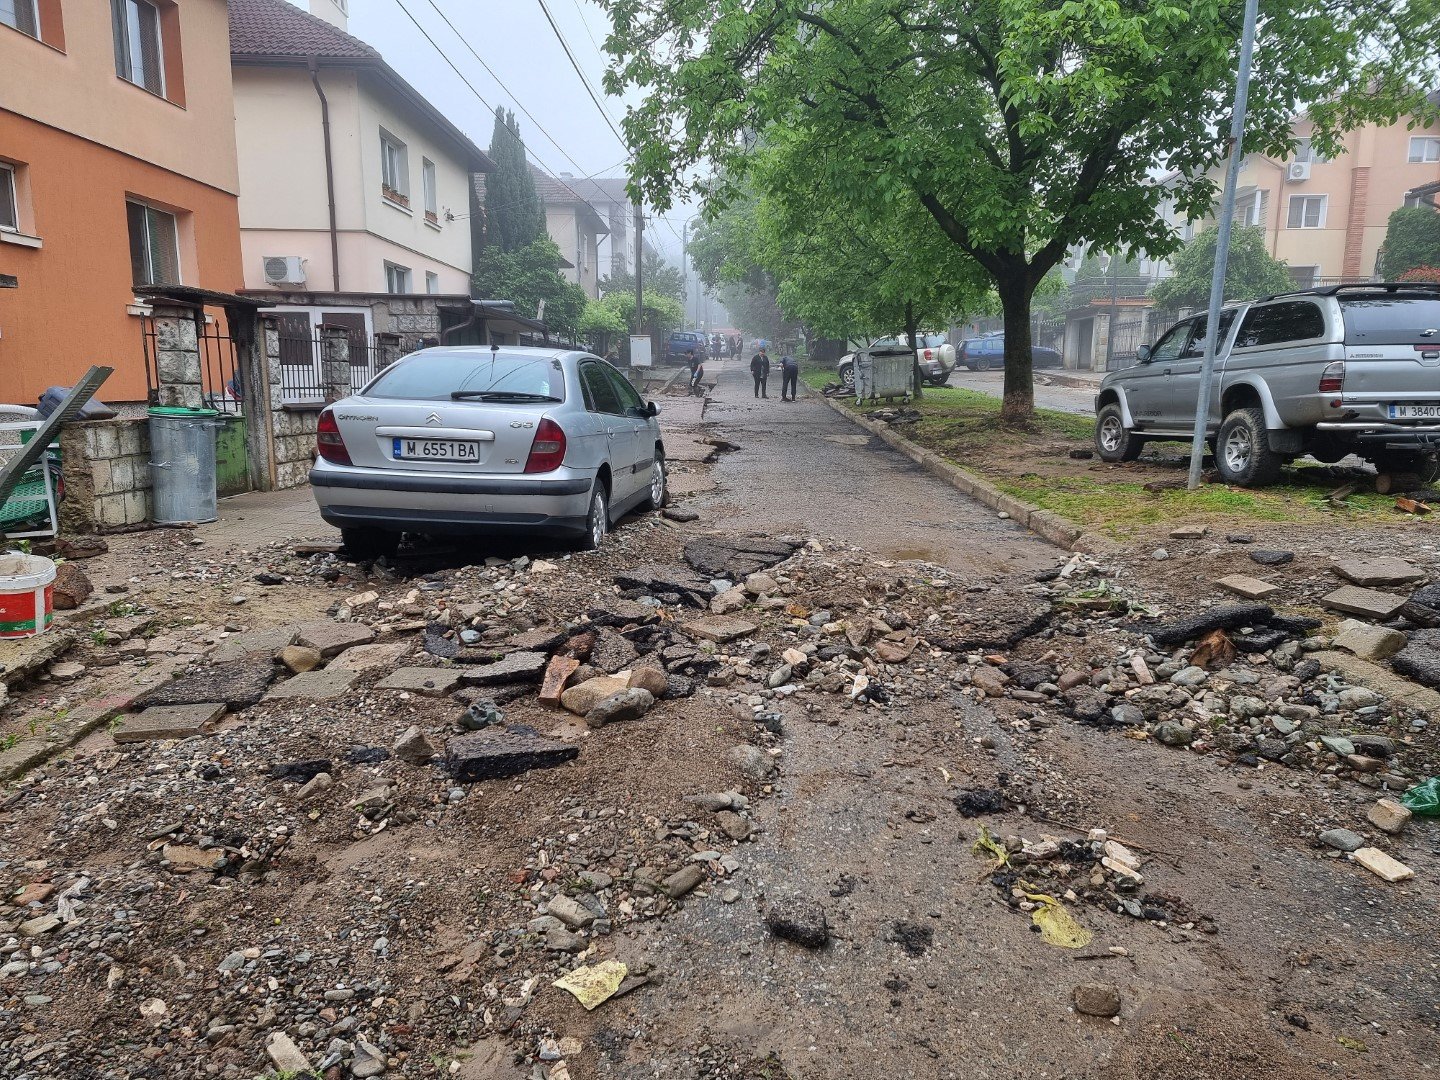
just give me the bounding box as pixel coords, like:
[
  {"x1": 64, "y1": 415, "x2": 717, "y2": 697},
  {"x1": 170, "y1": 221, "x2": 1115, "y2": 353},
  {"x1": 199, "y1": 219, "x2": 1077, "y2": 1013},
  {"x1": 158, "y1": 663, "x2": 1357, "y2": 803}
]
[{"x1": 0, "y1": 0, "x2": 245, "y2": 403}]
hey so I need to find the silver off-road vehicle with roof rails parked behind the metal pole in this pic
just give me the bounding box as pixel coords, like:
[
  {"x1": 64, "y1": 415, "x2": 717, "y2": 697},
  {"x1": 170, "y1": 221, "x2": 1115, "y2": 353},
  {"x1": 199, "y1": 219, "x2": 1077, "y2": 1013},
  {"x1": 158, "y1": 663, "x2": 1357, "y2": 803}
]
[{"x1": 1094, "y1": 284, "x2": 1440, "y2": 487}]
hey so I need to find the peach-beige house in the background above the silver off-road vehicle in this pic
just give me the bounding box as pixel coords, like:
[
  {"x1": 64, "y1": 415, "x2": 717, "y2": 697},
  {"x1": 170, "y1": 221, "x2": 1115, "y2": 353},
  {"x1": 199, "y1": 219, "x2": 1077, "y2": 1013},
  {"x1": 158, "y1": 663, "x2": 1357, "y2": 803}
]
[{"x1": 1159, "y1": 117, "x2": 1440, "y2": 288}]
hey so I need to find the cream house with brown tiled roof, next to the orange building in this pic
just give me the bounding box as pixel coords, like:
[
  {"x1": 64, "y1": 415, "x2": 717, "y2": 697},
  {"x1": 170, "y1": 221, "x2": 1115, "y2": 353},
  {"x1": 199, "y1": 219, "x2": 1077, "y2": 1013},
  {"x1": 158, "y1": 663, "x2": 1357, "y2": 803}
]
[{"x1": 229, "y1": 0, "x2": 491, "y2": 311}]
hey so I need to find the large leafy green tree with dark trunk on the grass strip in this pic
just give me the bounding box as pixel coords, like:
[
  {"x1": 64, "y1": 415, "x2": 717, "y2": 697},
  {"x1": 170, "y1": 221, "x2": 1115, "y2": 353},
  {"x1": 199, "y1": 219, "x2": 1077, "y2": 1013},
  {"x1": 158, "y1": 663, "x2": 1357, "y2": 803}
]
[{"x1": 602, "y1": 0, "x2": 1440, "y2": 420}]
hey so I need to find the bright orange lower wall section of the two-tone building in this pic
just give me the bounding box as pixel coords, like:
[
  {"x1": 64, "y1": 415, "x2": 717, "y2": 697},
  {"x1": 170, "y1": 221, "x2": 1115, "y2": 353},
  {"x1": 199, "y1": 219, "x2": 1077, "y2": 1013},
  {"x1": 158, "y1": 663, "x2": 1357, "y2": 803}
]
[{"x1": 0, "y1": 112, "x2": 243, "y2": 402}]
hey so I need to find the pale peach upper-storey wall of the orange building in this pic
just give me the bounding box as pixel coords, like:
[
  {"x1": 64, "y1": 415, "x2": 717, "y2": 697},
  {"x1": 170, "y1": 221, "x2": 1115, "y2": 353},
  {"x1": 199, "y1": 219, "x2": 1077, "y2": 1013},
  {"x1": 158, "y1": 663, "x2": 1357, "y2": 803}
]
[{"x1": 0, "y1": 0, "x2": 239, "y2": 194}]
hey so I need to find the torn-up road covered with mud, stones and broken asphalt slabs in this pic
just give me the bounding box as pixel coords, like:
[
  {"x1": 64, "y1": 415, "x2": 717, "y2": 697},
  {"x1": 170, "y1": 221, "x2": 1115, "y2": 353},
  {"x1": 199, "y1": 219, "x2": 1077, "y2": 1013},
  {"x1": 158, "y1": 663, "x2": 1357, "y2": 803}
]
[{"x1": 0, "y1": 363, "x2": 1440, "y2": 1080}]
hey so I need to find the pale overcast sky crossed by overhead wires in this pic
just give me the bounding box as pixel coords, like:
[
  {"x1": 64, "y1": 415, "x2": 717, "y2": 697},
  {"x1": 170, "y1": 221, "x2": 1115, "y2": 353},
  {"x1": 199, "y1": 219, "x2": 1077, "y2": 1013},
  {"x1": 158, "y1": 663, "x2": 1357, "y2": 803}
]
[{"x1": 336, "y1": 0, "x2": 694, "y2": 264}]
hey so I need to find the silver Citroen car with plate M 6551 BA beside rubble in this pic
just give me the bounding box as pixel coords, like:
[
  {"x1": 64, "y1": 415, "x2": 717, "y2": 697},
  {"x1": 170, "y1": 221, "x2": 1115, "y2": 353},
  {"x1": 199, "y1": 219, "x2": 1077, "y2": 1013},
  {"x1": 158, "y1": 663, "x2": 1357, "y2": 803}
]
[{"x1": 310, "y1": 346, "x2": 665, "y2": 556}]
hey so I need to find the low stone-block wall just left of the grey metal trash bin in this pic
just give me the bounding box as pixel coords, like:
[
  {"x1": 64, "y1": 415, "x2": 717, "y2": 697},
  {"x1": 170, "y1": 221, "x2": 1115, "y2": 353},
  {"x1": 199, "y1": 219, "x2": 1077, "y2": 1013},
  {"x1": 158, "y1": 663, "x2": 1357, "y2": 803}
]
[{"x1": 60, "y1": 418, "x2": 151, "y2": 533}]
